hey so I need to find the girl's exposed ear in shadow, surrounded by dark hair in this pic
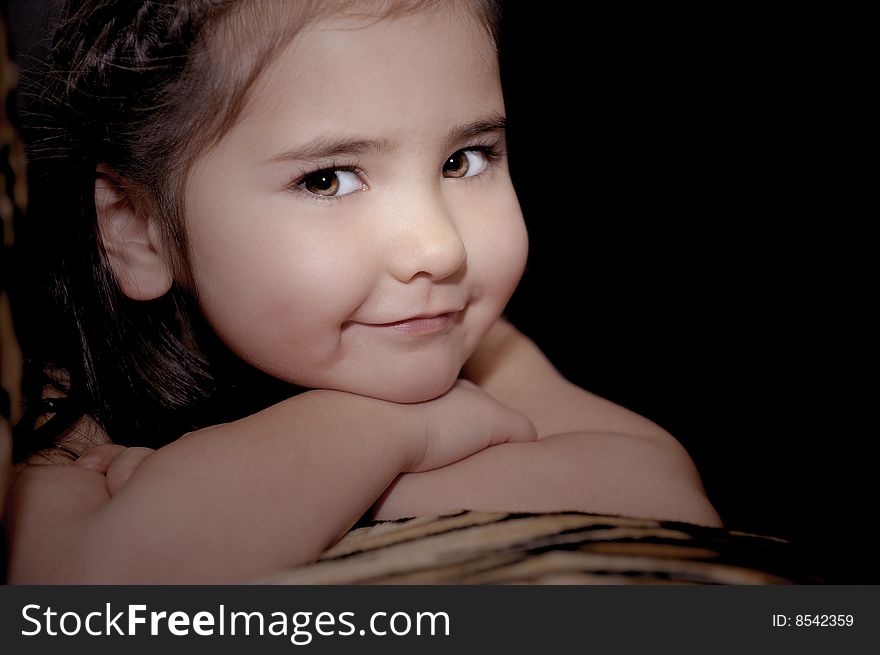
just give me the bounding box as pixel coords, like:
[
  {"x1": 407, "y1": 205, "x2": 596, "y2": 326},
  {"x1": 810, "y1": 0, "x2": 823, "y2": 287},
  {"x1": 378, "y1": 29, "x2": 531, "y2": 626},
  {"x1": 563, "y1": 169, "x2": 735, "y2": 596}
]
[{"x1": 95, "y1": 166, "x2": 173, "y2": 300}]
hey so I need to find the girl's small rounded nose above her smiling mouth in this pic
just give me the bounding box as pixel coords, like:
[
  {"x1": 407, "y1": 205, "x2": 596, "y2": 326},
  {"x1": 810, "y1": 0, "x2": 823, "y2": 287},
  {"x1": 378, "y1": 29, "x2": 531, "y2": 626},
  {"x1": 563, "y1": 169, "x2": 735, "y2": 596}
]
[{"x1": 389, "y1": 190, "x2": 467, "y2": 282}]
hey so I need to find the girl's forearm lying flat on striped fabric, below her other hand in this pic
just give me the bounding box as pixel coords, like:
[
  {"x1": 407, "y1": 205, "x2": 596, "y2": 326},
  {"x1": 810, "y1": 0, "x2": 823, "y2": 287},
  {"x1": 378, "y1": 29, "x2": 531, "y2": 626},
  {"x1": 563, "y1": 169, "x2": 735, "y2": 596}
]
[{"x1": 372, "y1": 432, "x2": 721, "y2": 526}]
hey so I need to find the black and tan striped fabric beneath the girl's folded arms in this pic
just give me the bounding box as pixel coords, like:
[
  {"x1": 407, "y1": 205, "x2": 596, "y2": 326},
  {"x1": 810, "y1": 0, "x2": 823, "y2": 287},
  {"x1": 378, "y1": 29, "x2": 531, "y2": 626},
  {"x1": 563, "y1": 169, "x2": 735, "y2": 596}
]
[{"x1": 259, "y1": 511, "x2": 821, "y2": 584}]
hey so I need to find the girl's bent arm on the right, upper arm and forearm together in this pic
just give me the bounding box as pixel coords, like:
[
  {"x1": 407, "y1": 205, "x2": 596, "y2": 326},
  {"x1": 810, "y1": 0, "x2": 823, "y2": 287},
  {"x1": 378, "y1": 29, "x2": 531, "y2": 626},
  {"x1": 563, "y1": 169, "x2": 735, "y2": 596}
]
[{"x1": 373, "y1": 321, "x2": 720, "y2": 525}]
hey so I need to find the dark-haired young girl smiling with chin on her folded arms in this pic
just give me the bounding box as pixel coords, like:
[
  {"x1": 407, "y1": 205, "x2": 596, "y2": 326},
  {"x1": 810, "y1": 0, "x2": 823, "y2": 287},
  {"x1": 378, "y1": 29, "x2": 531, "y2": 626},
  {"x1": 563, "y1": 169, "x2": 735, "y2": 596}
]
[{"x1": 7, "y1": 0, "x2": 718, "y2": 583}]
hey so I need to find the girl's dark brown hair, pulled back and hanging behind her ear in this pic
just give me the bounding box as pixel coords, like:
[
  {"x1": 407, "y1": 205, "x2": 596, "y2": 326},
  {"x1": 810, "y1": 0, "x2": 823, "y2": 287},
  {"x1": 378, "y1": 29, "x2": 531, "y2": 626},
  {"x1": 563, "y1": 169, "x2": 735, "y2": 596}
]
[{"x1": 15, "y1": 0, "x2": 499, "y2": 460}]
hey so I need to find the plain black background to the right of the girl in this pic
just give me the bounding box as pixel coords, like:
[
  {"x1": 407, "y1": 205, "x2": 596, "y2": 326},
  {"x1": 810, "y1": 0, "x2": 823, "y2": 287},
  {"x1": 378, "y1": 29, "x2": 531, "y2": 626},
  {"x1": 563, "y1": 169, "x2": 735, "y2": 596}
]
[{"x1": 502, "y1": 2, "x2": 880, "y2": 582}]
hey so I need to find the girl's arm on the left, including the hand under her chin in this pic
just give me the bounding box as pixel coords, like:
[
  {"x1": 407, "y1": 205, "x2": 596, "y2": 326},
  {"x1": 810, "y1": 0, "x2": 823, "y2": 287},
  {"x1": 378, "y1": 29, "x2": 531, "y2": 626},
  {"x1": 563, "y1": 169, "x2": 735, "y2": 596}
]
[{"x1": 7, "y1": 383, "x2": 534, "y2": 584}]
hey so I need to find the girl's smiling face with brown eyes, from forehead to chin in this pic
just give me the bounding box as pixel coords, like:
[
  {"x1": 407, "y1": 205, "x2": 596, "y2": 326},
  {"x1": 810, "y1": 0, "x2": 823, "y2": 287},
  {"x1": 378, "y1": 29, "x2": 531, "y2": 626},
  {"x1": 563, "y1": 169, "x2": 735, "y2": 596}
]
[{"x1": 186, "y1": 3, "x2": 527, "y2": 402}]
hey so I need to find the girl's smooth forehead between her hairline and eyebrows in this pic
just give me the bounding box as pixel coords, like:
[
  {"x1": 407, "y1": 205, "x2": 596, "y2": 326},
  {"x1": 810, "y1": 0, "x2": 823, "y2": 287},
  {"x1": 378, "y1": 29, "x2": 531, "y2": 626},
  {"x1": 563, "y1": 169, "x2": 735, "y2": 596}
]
[{"x1": 238, "y1": 2, "x2": 503, "y2": 144}]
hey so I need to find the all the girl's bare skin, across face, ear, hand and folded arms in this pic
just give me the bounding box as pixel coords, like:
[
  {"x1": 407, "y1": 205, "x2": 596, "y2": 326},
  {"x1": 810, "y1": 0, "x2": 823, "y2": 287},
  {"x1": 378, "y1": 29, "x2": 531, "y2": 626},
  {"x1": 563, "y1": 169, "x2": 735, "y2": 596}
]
[{"x1": 3, "y1": 3, "x2": 719, "y2": 583}]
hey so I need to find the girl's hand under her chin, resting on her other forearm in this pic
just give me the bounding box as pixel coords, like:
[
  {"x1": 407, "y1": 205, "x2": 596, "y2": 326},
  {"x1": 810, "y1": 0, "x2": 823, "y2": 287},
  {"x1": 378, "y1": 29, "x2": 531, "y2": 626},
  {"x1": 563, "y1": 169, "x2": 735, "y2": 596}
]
[{"x1": 407, "y1": 380, "x2": 537, "y2": 473}]
